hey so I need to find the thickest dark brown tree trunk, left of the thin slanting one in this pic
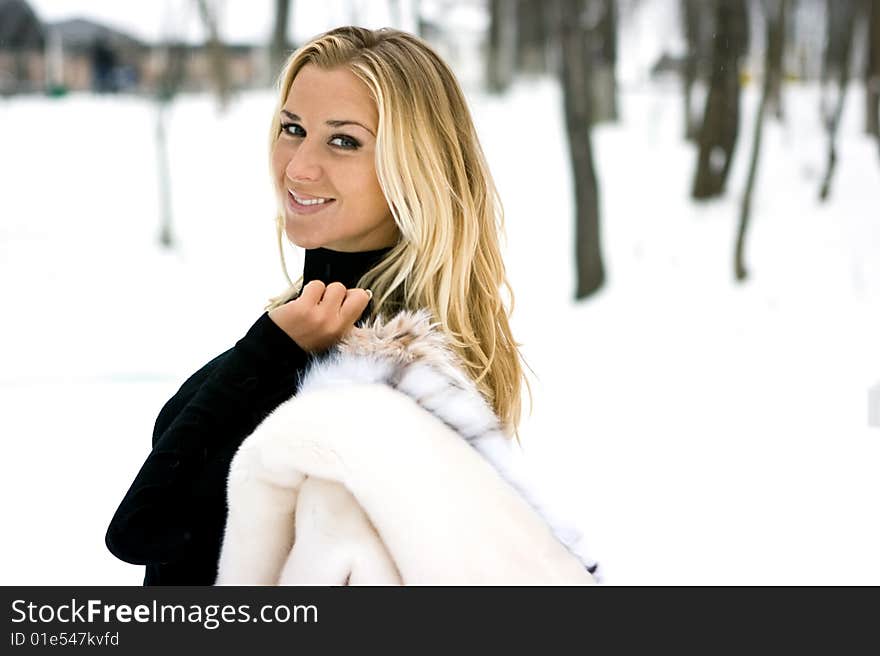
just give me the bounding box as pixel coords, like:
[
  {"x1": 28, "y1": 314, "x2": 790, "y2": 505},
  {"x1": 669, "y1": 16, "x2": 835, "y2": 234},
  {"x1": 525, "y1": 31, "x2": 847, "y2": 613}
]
[{"x1": 692, "y1": 0, "x2": 748, "y2": 200}]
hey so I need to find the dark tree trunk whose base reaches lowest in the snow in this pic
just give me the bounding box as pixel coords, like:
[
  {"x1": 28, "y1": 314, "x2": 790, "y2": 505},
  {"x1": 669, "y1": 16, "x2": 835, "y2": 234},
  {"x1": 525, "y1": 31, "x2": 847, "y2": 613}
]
[{"x1": 558, "y1": 0, "x2": 605, "y2": 299}]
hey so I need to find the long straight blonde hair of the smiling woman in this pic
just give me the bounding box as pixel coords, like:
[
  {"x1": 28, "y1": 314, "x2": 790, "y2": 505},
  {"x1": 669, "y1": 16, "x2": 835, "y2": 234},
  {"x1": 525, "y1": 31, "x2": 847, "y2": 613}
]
[{"x1": 267, "y1": 27, "x2": 531, "y2": 437}]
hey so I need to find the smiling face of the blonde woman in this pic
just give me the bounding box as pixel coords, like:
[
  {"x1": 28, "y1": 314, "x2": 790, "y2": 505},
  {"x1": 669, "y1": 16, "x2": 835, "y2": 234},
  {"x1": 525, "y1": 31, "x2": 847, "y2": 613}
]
[{"x1": 272, "y1": 64, "x2": 398, "y2": 252}]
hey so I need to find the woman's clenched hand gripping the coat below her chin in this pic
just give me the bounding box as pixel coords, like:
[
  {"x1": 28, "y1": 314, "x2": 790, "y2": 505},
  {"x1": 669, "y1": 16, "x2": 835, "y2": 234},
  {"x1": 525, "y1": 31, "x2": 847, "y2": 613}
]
[{"x1": 269, "y1": 280, "x2": 373, "y2": 352}]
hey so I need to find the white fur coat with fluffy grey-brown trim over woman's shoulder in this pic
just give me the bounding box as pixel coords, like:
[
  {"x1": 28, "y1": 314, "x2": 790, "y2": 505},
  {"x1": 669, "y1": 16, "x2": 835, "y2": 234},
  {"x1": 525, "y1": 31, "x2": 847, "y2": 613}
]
[{"x1": 217, "y1": 312, "x2": 593, "y2": 585}]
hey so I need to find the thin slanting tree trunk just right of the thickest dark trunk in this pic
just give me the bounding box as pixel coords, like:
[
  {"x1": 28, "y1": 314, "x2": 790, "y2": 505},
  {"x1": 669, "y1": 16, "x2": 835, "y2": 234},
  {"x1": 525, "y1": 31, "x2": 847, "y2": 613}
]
[{"x1": 733, "y1": 0, "x2": 788, "y2": 280}]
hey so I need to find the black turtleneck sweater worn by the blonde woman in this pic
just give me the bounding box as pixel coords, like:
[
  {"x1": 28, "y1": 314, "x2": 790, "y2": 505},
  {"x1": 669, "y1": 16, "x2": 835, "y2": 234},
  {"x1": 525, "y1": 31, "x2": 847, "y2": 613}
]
[{"x1": 105, "y1": 248, "x2": 391, "y2": 585}]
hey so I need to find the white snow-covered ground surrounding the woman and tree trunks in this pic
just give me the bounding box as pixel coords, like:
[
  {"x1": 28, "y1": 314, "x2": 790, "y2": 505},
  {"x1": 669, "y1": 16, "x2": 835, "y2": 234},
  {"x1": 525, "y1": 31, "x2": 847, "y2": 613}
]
[{"x1": 0, "y1": 72, "x2": 880, "y2": 584}]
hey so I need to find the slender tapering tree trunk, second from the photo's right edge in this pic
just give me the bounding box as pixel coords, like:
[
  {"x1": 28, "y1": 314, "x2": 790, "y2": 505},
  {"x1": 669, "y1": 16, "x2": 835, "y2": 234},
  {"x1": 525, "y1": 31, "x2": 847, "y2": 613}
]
[{"x1": 819, "y1": 0, "x2": 858, "y2": 202}]
